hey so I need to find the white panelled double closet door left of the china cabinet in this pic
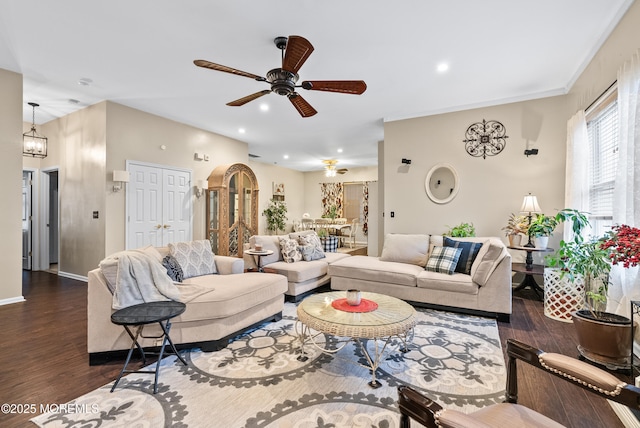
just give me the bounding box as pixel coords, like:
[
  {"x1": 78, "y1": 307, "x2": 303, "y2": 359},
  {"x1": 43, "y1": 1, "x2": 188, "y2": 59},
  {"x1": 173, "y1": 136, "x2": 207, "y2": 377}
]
[{"x1": 127, "y1": 163, "x2": 191, "y2": 248}]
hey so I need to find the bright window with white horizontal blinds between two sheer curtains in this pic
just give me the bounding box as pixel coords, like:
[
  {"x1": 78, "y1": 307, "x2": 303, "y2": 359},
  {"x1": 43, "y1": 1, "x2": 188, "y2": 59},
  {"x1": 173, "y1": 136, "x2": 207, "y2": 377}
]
[{"x1": 586, "y1": 88, "x2": 618, "y2": 236}]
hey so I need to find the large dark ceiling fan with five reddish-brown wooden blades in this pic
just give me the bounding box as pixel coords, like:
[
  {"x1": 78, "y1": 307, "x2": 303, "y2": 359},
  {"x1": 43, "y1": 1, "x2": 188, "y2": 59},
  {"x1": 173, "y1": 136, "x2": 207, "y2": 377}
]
[{"x1": 193, "y1": 36, "x2": 367, "y2": 117}]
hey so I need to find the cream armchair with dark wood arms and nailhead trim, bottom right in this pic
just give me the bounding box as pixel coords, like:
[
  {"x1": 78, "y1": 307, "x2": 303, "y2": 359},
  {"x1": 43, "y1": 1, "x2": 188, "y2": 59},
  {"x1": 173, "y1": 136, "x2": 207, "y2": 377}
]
[{"x1": 398, "y1": 339, "x2": 640, "y2": 428}]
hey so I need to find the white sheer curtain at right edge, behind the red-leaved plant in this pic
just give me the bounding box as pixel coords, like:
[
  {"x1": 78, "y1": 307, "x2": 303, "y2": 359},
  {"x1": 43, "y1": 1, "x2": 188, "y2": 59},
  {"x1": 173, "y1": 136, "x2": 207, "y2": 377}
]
[{"x1": 607, "y1": 50, "x2": 640, "y2": 316}]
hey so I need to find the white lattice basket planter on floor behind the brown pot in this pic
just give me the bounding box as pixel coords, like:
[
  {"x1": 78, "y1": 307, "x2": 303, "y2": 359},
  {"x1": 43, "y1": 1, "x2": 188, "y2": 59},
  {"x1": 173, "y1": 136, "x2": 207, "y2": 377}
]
[{"x1": 544, "y1": 268, "x2": 586, "y2": 322}]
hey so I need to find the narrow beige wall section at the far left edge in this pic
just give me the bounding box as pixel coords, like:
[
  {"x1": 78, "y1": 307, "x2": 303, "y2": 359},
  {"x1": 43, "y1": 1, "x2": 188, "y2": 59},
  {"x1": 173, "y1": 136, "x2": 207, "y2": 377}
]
[{"x1": 0, "y1": 69, "x2": 23, "y2": 304}]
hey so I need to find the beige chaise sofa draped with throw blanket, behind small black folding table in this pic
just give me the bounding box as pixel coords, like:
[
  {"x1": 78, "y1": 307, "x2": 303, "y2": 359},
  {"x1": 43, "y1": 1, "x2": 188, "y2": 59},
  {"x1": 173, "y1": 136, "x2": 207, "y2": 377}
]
[{"x1": 87, "y1": 247, "x2": 287, "y2": 364}]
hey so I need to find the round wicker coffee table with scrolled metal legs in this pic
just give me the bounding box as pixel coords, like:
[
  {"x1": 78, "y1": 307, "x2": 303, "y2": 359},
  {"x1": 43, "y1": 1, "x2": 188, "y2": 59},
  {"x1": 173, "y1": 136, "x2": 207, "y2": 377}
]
[{"x1": 296, "y1": 291, "x2": 416, "y2": 388}]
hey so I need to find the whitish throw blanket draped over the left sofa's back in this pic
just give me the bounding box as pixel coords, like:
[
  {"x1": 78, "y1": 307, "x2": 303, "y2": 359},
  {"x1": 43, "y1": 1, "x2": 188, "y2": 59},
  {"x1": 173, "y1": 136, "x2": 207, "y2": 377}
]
[{"x1": 112, "y1": 251, "x2": 181, "y2": 309}]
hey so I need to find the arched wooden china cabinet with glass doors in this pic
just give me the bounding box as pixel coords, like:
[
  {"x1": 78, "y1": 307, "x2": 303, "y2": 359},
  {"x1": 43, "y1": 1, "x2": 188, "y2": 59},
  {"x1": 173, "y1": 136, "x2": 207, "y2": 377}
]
[{"x1": 206, "y1": 163, "x2": 258, "y2": 257}]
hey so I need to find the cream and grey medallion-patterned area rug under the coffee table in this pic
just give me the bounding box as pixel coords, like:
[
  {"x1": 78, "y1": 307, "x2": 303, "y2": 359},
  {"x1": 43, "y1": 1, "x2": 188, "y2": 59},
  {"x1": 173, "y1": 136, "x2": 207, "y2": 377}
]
[{"x1": 32, "y1": 303, "x2": 506, "y2": 428}]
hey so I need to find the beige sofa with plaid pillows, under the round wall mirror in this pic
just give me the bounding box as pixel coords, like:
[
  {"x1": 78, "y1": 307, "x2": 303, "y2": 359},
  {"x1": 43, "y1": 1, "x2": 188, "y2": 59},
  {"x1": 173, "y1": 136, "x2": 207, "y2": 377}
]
[{"x1": 329, "y1": 235, "x2": 512, "y2": 321}]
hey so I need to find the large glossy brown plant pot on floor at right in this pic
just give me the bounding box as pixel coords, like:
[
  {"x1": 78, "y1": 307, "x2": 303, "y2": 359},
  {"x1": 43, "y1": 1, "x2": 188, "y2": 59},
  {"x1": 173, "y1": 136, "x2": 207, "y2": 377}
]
[{"x1": 573, "y1": 309, "x2": 632, "y2": 370}]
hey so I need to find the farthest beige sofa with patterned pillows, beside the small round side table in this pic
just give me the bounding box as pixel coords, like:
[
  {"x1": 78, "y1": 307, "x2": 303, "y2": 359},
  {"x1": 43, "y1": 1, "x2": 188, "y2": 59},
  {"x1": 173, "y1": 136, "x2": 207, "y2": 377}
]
[{"x1": 243, "y1": 231, "x2": 351, "y2": 302}]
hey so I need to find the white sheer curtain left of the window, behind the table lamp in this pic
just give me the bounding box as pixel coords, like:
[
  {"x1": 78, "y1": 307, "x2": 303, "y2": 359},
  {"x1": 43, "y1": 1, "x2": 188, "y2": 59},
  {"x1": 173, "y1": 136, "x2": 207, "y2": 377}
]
[{"x1": 563, "y1": 110, "x2": 589, "y2": 241}]
